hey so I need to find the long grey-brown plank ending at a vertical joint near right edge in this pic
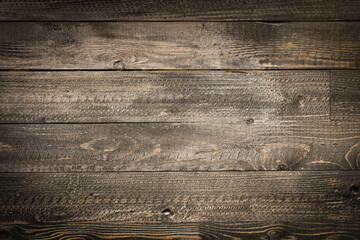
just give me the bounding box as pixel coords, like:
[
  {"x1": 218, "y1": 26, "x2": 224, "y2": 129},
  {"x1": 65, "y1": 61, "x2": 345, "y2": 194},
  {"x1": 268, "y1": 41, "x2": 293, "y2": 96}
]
[{"x1": 0, "y1": 71, "x2": 330, "y2": 123}]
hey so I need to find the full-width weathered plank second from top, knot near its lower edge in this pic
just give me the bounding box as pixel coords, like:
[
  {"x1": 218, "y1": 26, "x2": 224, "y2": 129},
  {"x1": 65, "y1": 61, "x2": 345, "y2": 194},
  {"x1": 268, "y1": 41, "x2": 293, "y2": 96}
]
[{"x1": 0, "y1": 22, "x2": 360, "y2": 69}]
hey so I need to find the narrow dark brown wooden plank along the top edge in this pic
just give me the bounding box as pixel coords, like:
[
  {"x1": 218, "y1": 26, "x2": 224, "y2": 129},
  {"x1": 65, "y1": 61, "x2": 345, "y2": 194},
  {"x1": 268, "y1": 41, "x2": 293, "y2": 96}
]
[{"x1": 0, "y1": 0, "x2": 360, "y2": 21}]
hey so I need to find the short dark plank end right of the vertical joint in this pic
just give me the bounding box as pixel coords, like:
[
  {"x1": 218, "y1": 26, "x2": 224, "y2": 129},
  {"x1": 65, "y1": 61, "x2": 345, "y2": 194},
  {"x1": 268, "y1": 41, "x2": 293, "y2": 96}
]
[{"x1": 331, "y1": 71, "x2": 360, "y2": 121}]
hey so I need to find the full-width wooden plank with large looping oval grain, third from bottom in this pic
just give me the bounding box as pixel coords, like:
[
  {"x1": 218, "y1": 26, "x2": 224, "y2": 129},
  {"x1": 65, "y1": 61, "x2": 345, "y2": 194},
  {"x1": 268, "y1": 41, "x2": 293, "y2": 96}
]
[{"x1": 0, "y1": 120, "x2": 360, "y2": 172}]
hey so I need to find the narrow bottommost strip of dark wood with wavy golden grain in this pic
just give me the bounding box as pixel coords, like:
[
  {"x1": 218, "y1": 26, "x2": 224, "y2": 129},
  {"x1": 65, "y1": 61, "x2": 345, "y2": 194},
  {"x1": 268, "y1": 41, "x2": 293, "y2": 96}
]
[{"x1": 0, "y1": 222, "x2": 360, "y2": 240}]
